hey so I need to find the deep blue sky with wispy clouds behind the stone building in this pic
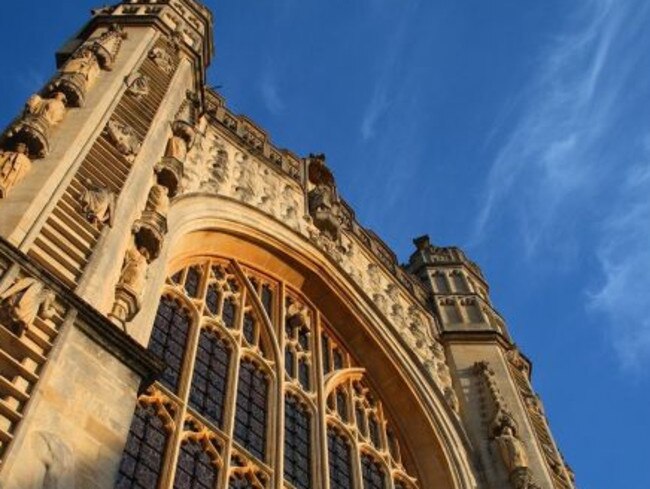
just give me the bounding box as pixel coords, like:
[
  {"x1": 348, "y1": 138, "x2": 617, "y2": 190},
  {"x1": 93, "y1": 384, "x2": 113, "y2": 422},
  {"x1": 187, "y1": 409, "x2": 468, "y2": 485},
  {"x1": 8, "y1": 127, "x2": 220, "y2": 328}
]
[{"x1": 0, "y1": 0, "x2": 650, "y2": 489}]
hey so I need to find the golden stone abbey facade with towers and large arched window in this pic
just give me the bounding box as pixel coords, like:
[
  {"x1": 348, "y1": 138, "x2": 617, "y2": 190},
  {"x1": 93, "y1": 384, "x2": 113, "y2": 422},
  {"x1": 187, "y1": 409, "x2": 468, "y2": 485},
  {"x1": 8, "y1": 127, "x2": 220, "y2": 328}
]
[{"x1": 0, "y1": 0, "x2": 574, "y2": 489}]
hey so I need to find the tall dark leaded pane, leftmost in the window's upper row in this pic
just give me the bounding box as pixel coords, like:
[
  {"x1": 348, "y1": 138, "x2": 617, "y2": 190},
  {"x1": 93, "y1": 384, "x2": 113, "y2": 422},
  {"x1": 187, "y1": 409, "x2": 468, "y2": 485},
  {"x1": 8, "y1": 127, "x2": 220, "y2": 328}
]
[{"x1": 149, "y1": 297, "x2": 190, "y2": 391}]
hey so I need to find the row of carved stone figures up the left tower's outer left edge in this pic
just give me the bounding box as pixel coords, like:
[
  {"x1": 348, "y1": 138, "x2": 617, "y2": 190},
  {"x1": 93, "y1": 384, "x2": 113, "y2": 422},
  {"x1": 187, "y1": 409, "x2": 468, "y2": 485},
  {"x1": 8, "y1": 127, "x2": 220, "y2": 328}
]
[{"x1": 0, "y1": 25, "x2": 126, "y2": 198}]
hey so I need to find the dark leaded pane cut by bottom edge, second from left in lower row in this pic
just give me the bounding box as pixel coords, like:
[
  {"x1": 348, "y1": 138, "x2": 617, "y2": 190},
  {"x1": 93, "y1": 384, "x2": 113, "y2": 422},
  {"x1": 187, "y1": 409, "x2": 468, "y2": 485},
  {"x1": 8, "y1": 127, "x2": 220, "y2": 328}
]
[{"x1": 172, "y1": 441, "x2": 219, "y2": 489}]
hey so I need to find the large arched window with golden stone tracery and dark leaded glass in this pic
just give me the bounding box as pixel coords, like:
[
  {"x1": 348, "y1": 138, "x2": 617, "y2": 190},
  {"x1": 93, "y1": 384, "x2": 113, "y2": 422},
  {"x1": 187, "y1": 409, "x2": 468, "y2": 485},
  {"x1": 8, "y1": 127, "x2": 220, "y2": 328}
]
[{"x1": 117, "y1": 257, "x2": 419, "y2": 489}]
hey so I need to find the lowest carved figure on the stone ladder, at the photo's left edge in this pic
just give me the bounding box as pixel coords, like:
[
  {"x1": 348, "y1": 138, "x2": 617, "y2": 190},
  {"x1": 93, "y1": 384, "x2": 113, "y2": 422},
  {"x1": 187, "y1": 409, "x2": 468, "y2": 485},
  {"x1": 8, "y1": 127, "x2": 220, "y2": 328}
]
[{"x1": 0, "y1": 277, "x2": 56, "y2": 335}]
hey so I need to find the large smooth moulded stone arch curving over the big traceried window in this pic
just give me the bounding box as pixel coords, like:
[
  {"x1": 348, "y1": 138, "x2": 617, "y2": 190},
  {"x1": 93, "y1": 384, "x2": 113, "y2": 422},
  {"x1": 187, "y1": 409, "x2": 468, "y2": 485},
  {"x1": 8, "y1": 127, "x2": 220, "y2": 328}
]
[{"x1": 143, "y1": 194, "x2": 476, "y2": 489}]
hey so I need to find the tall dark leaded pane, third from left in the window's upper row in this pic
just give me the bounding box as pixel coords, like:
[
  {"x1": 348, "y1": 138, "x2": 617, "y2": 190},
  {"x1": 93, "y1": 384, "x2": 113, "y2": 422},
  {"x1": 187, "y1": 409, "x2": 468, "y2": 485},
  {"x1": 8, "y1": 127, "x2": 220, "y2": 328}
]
[{"x1": 235, "y1": 359, "x2": 268, "y2": 460}]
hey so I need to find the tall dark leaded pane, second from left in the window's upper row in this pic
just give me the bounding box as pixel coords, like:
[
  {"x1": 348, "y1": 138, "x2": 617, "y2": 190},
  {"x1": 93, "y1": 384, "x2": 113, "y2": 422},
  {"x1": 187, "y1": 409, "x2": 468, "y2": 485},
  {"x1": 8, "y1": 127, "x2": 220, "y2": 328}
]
[{"x1": 190, "y1": 330, "x2": 230, "y2": 427}]
